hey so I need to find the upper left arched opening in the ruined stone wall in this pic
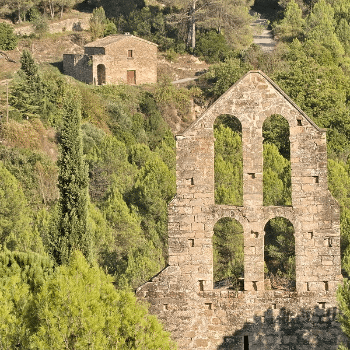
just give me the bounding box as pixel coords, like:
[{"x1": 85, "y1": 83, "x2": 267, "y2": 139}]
[{"x1": 214, "y1": 115, "x2": 243, "y2": 206}]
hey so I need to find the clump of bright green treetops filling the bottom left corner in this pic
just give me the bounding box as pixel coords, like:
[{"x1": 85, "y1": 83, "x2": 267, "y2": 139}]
[{"x1": 0, "y1": 252, "x2": 174, "y2": 350}]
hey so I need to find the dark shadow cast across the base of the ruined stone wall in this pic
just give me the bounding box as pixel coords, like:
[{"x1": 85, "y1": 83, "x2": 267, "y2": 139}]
[{"x1": 217, "y1": 303, "x2": 350, "y2": 350}]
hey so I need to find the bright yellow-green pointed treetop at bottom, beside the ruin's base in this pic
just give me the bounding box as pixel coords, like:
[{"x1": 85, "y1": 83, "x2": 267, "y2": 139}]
[{"x1": 30, "y1": 252, "x2": 174, "y2": 350}]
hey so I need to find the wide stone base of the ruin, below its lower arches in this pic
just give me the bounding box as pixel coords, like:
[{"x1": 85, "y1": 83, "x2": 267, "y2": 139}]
[{"x1": 137, "y1": 284, "x2": 348, "y2": 350}]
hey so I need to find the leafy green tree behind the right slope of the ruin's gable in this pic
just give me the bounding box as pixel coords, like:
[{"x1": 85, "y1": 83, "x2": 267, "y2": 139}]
[{"x1": 274, "y1": 40, "x2": 350, "y2": 156}]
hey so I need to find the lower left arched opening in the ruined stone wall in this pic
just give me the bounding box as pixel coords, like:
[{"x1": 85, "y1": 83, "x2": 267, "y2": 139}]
[{"x1": 213, "y1": 218, "x2": 244, "y2": 290}]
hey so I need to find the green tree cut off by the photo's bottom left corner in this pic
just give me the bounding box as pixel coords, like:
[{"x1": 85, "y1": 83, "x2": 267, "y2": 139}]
[{"x1": 0, "y1": 251, "x2": 53, "y2": 349}]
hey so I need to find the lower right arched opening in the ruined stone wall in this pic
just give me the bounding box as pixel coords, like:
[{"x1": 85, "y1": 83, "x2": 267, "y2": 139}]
[{"x1": 264, "y1": 217, "x2": 295, "y2": 291}]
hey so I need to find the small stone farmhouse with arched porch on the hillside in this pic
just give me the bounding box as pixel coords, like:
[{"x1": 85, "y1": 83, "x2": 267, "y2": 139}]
[{"x1": 63, "y1": 33, "x2": 158, "y2": 85}]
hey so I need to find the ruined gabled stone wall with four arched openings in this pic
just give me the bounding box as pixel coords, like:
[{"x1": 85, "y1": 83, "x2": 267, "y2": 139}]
[{"x1": 137, "y1": 71, "x2": 345, "y2": 350}]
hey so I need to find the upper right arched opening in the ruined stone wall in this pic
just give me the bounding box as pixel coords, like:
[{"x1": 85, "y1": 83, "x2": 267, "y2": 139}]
[{"x1": 262, "y1": 114, "x2": 292, "y2": 206}]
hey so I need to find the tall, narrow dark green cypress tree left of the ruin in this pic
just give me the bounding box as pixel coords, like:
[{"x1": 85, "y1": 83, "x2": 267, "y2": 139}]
[{"x1": 53, "y1": 89, "x2": 90, "y2": 264}]
